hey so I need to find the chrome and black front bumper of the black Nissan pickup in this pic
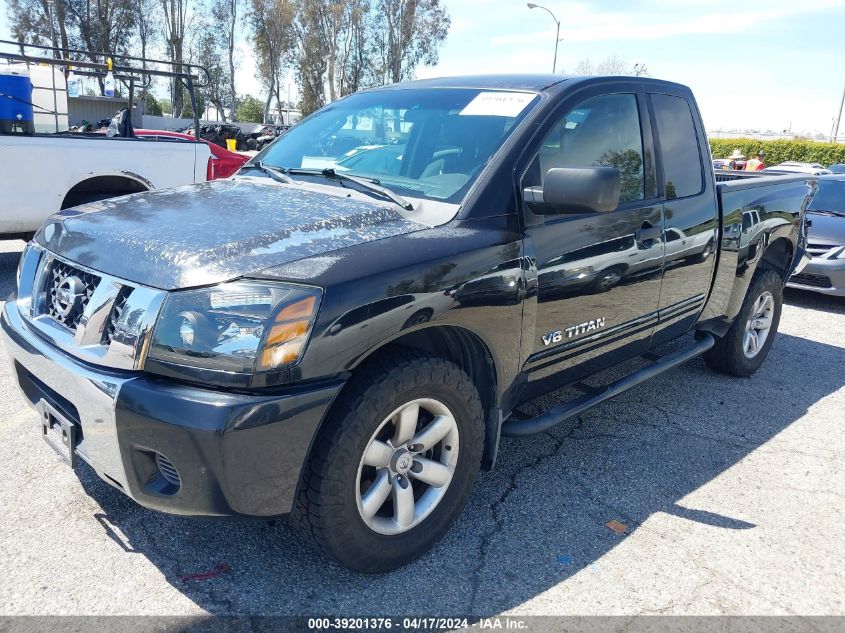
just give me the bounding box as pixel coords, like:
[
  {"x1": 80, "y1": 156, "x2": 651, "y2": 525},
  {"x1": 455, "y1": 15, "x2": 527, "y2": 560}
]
[{"x1": 1, "y1": 299, "x2": 342, "y2": 517}]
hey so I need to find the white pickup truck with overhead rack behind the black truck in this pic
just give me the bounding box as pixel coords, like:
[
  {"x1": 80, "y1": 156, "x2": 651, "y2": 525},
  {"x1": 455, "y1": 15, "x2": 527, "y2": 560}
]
[{"x1": 0, "y1": 41, "x2": 212, "y2": 239}]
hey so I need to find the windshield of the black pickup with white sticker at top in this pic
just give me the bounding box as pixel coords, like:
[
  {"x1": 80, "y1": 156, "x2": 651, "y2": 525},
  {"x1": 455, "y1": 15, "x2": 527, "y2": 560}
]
[{"x1": 256, "y1": 88, "x2": 537, "y2": 203}]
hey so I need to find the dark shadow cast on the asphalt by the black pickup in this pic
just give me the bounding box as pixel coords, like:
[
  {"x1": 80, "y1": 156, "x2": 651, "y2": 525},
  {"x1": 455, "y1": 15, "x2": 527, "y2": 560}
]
[{"x1": 80, "y1": 335, "x2": 843, "y2": 616}]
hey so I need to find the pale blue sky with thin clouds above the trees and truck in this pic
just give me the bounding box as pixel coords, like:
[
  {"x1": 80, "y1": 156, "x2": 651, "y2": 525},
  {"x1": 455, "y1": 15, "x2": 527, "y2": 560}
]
[{"x1": 0, "y1": 0, "x2": 845, "y2": 134}]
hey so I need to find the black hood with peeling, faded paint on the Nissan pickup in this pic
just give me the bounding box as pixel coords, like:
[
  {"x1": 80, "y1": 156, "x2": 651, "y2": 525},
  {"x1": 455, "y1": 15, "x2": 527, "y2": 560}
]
[{"x1": 35, "y1": 178, "x2": 426, "y2": 290}]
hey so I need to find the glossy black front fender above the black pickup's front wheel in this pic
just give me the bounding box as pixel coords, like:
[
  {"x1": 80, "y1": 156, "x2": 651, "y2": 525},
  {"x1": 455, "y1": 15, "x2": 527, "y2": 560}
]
[{"x1": 275, "y1": 218, "x2": 529, "y2": 404}]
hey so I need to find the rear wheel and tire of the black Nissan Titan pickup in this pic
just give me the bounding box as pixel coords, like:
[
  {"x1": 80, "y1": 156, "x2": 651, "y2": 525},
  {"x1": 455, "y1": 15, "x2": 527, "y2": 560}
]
[{"x1": 704, "y1": 270, "x2": 783, "y2": 378}]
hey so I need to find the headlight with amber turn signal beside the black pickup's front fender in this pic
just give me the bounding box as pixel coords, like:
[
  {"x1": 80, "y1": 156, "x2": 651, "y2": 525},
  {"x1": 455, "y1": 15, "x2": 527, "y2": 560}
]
[{"x1": 148, "y1": 281, "x2": 320, "y2": 373}]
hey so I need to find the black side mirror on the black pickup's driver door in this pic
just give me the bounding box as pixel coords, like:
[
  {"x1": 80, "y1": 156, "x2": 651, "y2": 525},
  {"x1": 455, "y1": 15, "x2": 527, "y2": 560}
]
[{"x1": 523, "y1": 167, "x2": 622, "y2": 215}]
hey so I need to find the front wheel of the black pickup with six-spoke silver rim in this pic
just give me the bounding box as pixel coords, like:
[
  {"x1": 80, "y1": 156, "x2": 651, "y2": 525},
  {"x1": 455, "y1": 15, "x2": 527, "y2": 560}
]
[{"x1": 293, "y1": 348, "x2": 484, "y2": 573}]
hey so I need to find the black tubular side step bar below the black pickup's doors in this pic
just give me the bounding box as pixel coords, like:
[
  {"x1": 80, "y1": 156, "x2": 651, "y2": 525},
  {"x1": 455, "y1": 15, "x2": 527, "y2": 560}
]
[{"x1": 502, "y1": 332, "x2": 716, "y2": 437}]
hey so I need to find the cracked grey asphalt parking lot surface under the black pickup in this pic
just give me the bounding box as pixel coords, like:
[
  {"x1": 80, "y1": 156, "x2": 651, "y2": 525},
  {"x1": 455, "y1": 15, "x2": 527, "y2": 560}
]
[{"x1": 0, "y1": 242, "x2": 845, "y2": 615}]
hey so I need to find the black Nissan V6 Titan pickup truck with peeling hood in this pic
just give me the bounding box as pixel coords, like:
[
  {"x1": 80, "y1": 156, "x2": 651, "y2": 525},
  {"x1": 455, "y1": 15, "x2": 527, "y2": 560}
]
[{"x1": 2, "y1": 76, "x2": 816, "y2": 571}]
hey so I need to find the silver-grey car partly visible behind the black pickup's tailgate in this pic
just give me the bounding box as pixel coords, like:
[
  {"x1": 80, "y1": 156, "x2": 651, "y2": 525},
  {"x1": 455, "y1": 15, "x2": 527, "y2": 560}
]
[{"x1": 787, "y1": 174, "x2": 845, "y2": 297}]
